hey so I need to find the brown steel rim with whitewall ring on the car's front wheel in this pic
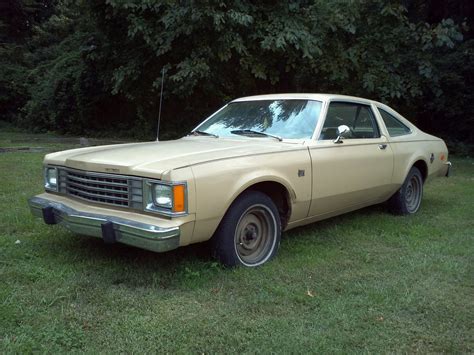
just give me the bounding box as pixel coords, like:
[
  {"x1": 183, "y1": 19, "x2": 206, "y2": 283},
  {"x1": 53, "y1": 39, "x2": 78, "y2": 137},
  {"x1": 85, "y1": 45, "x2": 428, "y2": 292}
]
[{"x1": 234, "y1": 205, "x2": 277, "y2": 266}]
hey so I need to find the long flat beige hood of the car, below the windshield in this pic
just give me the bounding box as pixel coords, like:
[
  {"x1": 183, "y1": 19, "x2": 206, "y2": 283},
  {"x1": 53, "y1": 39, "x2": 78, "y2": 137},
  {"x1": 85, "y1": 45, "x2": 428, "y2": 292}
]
[{"x1": 44, "y1": 137, "x2": 301, "y2": 179}]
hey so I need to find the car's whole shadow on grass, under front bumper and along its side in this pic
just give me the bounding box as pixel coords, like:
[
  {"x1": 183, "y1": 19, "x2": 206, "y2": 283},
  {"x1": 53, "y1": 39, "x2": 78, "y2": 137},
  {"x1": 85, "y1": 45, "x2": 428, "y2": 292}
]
[{"x1": 32, "y1": 198, "x2": 434, "y2": 290}]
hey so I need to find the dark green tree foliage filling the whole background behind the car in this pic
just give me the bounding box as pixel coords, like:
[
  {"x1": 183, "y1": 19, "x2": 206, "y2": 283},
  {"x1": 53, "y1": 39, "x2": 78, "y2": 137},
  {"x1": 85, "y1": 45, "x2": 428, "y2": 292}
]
[{"x1": 0, "y1": 0, "x2": 473, "y2": 146}]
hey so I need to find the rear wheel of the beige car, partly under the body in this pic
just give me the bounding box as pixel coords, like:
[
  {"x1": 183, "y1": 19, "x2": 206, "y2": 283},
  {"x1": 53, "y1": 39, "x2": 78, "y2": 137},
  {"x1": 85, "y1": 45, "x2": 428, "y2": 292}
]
[{"x1": 388, "y1": 166, "x2": 423, "y2": 215}]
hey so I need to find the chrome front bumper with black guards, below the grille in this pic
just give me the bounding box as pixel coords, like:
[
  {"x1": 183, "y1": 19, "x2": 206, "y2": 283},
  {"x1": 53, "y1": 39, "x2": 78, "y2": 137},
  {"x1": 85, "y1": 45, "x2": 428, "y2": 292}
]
[{"x1": 28, "y1": 197, "x2": 180, "y2": 252}]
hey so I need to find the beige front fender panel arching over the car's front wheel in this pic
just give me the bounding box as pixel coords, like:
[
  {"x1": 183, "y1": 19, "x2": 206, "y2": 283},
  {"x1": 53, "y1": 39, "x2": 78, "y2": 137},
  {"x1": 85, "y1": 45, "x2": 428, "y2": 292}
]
[{"x1": 187, "y1": 149, "x2": 311, "y2": 241}]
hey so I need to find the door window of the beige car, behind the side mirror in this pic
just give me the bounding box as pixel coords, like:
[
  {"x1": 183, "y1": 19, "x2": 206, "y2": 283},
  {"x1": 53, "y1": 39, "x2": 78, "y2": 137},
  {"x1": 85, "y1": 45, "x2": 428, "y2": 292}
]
[{"x1": 319, "y1": 102, "x2": 380, "y2": 140}]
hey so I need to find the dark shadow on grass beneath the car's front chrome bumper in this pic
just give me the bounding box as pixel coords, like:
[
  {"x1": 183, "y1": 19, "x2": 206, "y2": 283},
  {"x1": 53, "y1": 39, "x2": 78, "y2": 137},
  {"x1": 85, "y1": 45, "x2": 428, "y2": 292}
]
[{"x1": 34, "y1": 226, "x2": 218, "y2": 290}]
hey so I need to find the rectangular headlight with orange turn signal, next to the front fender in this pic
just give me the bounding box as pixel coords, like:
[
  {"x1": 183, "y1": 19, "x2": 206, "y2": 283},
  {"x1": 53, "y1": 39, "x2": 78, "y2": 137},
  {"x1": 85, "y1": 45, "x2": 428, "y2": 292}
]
[{"x1": 144, "y1": 181, "x2": 186, "y2": 215}]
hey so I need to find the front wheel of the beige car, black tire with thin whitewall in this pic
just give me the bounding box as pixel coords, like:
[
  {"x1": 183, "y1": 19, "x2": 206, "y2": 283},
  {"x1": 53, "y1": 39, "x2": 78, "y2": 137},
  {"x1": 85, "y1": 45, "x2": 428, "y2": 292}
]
[{"x1": 211, "y1": 191, "x2": 281, "y2": 267}]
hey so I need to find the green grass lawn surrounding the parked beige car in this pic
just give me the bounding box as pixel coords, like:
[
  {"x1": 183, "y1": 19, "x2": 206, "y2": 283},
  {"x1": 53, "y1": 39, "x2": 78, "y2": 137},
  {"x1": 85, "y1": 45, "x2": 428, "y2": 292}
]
[{"x1": 0, "y1": 131, "x2": 474, "y2": 353}]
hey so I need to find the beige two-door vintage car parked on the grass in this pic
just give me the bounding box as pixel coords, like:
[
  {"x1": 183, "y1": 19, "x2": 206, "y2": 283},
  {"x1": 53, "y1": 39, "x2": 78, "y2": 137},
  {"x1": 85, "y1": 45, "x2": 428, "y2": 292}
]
[{"x1": 29, "y1": 94, "x2": 451, "y2": 267}]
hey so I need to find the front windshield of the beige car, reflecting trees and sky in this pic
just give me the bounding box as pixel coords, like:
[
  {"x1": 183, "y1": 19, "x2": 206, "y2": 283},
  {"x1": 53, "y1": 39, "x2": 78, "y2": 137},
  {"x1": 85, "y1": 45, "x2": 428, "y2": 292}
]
[{"x1": 193, "y1": 100, "x2": 321, "y2": 139}]
